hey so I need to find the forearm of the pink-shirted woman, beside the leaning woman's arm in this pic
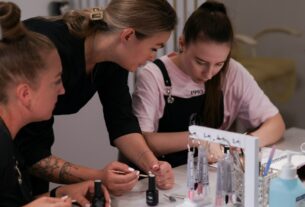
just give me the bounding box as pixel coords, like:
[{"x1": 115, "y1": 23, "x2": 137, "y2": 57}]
[{"x1": 143, "y1": 132, "x2": 191, "y2": 155}]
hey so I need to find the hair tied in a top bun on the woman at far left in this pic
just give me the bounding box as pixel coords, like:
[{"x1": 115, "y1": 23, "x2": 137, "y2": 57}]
[{"x1": 0, "y1": 1, "x2": 55, "y2": 103}]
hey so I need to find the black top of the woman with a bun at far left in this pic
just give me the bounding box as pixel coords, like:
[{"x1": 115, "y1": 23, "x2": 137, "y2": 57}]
[{"x1": 0, "y1": 119, "x2": 32, "y2": 207}]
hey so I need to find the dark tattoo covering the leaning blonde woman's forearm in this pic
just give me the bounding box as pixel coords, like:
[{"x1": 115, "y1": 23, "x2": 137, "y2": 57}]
[{"x1": 30, "y1": 156, "x2": 84, "y2": 184}]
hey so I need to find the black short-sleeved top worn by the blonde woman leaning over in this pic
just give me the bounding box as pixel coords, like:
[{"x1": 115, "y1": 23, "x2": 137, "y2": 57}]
[{"x1": 15, "y1": 18, "x2": 141, "y2": 194}]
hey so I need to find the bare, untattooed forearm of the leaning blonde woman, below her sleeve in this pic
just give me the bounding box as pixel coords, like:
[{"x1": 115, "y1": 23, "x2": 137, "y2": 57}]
[{"x1": 114, "y1": 133, "x2": 158, "y2": 171}]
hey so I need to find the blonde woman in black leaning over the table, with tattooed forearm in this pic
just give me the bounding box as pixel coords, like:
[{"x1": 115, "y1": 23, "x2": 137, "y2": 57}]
[{"x1": 15, "y1": 0, "x2": 176, "y2": 195}]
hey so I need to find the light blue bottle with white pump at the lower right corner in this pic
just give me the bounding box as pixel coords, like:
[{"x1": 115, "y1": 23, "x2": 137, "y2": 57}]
[{"x1": 269, "y1": 152, "x2": 305, "y2": 207}]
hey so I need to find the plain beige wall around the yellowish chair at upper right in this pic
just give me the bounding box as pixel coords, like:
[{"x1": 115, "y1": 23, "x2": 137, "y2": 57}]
[{"x1": 223, "y1": 0, "x2": 305, "y2": 128}]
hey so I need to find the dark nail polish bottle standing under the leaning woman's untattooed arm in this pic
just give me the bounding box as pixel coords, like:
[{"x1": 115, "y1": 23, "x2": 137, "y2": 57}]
[{"x1": 146, "y1": 172, "x2": 159, "y2": 206}]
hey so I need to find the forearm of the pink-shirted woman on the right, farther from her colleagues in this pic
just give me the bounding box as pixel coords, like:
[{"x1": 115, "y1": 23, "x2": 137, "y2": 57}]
[{"x1": 251, "y1": 113, "x2": 285, "y2": 147}]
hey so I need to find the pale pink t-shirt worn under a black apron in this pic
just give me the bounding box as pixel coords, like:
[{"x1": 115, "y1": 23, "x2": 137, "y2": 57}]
[{"x1": 133, "y1": 56, "x2": 278, "y2": 132}]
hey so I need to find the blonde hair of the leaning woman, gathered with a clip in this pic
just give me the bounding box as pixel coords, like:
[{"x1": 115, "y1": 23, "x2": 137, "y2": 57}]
[{"x1": 62, "y1": 0, "x2": 177, "y2": 38}]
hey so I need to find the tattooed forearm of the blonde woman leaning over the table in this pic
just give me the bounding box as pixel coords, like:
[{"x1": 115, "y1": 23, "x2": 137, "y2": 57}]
[{"x1": 30, "y1": 155, "x2": 101, "y2": 184}]
